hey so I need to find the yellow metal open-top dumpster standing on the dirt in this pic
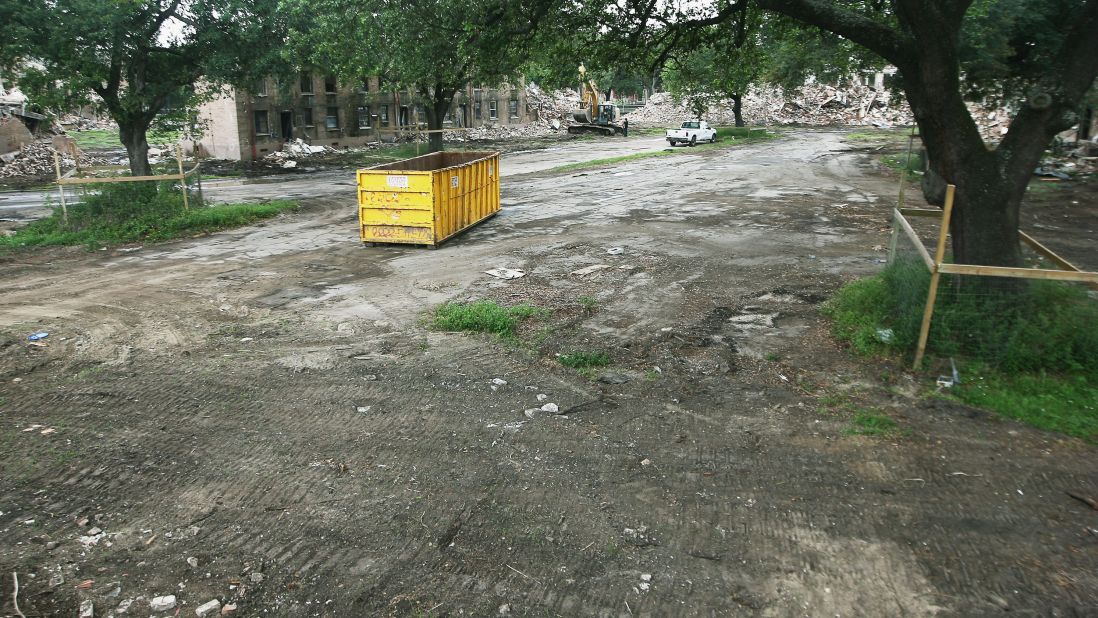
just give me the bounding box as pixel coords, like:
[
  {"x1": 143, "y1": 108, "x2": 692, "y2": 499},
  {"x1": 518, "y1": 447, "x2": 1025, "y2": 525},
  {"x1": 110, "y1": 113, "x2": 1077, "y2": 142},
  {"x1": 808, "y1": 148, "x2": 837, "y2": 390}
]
[{"x1": 358, "y1": 153, "x2": 500, "y2": 247}]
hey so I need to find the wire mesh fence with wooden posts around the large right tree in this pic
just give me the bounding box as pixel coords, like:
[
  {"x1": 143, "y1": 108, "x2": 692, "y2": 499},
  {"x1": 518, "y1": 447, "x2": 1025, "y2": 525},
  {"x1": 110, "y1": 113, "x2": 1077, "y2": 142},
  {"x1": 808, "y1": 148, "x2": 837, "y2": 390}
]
[{"x1": 877, "y1": 204, "x2": 1098, "y2": 373}]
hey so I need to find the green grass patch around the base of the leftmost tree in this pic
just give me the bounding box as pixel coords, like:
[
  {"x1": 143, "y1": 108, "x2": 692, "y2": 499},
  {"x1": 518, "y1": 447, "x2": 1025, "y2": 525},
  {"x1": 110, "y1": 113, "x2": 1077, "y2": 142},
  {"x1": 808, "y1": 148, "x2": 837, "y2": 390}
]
[{"x1": 0, "y1": 182, "x2": 298, "y2": 250}]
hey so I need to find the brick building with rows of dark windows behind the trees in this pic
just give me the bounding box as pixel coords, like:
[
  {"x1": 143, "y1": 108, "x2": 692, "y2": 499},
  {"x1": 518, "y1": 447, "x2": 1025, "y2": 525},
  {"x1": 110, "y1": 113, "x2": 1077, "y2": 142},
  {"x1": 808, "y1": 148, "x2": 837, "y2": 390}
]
[{"x1": 199, "y1": 71, "x2": 531, "y2": 161}]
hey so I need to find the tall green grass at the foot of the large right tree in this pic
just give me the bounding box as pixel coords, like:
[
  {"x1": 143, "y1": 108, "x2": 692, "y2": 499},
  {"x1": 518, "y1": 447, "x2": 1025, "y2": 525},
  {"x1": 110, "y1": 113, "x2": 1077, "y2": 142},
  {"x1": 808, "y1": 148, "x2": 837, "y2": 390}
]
[{"x1": 824, "y1": 262, "x2": 1098, "y2": 442}]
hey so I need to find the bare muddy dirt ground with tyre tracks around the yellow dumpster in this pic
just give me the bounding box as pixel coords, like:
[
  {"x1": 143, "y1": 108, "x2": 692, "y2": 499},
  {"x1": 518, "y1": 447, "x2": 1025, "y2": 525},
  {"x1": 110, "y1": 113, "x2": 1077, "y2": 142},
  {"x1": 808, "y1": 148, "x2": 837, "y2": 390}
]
[{"x1": 0, "y1": 131, "x2": 1098, "y2": 617}]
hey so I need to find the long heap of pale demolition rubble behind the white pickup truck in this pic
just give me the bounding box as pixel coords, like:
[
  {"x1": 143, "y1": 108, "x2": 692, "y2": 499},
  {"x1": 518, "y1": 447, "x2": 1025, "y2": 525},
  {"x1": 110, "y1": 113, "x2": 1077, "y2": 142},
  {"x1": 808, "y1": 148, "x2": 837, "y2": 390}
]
[{"x1": 627, "y1": 82, "x2": 1011, "y2": 139}]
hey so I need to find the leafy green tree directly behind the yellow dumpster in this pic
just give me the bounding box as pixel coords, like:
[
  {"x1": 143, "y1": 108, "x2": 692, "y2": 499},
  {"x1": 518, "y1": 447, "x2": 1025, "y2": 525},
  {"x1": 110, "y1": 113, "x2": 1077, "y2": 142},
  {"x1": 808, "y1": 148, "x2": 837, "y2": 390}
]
[{"x1": 282, "y1": 0, "x2": 548, "y2": 151}]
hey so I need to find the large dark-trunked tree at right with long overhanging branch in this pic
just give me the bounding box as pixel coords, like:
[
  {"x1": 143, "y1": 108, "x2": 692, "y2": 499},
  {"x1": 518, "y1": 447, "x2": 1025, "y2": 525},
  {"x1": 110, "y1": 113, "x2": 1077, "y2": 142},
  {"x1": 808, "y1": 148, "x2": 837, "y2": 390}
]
[{"x1": 570, "y1": 0, "x2": 1098, "y2": 271}]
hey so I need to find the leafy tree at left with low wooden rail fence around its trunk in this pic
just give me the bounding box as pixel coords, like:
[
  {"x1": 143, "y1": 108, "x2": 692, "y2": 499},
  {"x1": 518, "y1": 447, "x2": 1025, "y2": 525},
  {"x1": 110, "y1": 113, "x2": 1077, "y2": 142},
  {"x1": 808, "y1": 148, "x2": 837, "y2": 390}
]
[{"x1": 7, "y1": 0, "x2": 282, "y2": 176}]
